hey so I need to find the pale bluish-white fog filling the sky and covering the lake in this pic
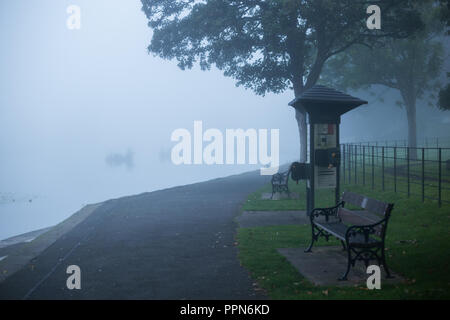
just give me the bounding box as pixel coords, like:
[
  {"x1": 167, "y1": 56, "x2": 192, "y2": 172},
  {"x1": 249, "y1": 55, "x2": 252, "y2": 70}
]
[{"x1": 0, "y1": 0, "x2": 449, "y2": 239}]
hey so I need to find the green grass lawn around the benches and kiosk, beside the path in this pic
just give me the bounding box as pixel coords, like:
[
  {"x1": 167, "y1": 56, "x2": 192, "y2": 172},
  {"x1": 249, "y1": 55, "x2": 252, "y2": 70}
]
[{"x1": 237, "y1": 180, "x2": 450, "y2": 299}]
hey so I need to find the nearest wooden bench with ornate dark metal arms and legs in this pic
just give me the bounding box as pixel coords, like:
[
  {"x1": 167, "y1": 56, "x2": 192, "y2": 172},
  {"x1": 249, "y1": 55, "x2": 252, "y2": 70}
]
[{"x1": 305, "y1": 192, "x2": 394, "y2": 280}]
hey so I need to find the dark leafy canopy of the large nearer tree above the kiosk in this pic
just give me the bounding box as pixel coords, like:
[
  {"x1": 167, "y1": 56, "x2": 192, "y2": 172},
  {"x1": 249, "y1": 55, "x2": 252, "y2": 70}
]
[{"x1": 142, "y1": 0, "x2": 421, "y2": 95}]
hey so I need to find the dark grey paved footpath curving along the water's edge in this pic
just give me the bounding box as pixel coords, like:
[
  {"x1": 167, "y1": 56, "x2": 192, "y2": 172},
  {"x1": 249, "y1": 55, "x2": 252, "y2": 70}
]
[{"x1": 0, "y1": 172, "x2": 270, "y2": 299}]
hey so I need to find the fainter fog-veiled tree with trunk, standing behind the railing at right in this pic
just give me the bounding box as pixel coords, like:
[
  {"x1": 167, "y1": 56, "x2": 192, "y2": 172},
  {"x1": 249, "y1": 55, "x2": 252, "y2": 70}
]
[{"x1": 321, "y1": 0, "x2": 445, "y2": 147}]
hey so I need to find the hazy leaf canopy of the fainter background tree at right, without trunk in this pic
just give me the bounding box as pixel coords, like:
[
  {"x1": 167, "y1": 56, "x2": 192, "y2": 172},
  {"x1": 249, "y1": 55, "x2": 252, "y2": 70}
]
[{"x1": 321, "y1": 35, "x2": 443, "y2": 104}]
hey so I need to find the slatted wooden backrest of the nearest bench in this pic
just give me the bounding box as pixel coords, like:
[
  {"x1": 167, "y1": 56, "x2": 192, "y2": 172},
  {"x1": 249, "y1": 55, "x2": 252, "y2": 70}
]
[{"x1": 338, "y1": 192, "x2": 393, "y2": 237}]
